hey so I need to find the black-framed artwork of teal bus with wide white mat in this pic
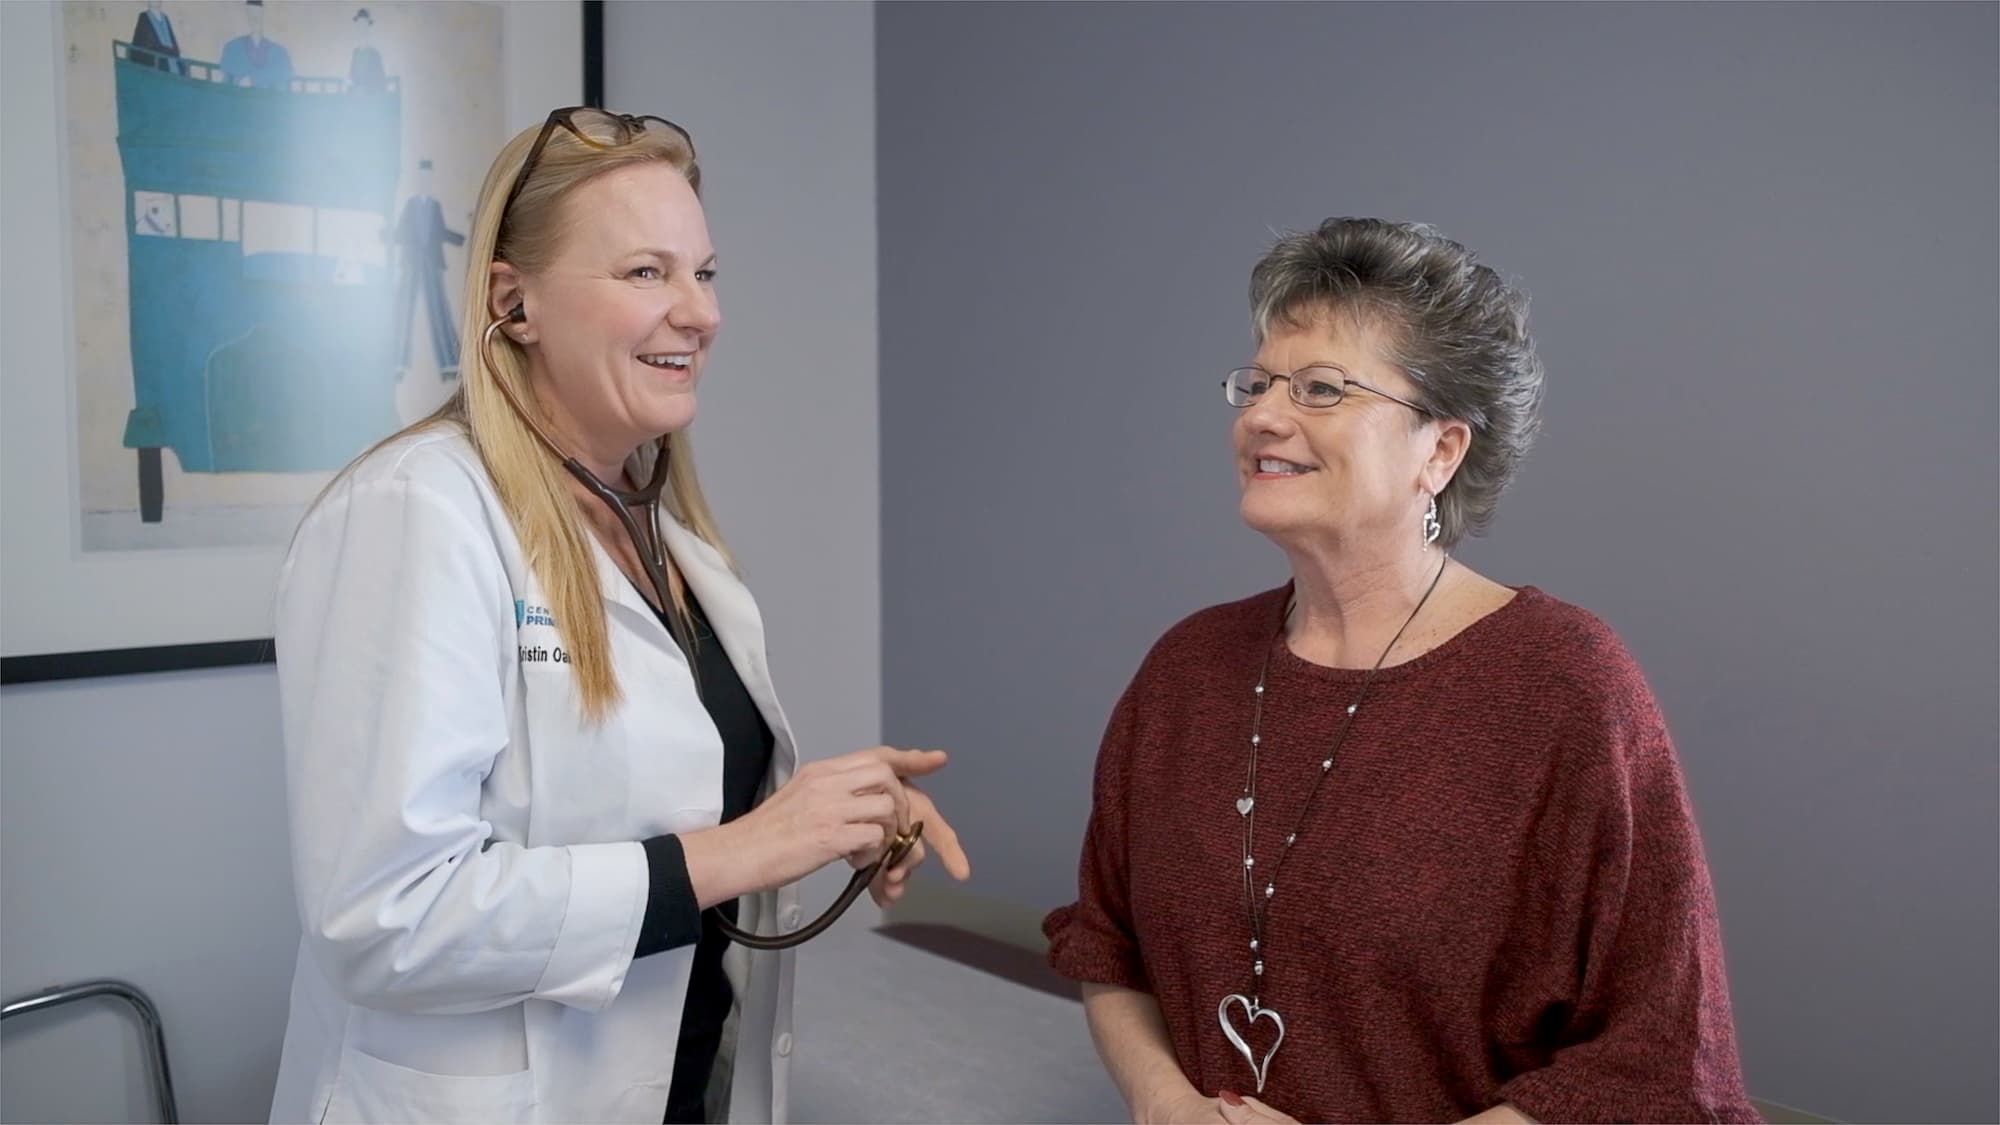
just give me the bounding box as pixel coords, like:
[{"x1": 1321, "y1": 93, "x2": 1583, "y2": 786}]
[{"x1": 0, "y1": 0, "x2": 602, "y2": 683}]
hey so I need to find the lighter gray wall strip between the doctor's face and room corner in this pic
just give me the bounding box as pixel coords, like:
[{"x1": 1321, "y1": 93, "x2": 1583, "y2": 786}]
[{"x1": 604, "y1": 2, "x2": 882, "y2": 912}]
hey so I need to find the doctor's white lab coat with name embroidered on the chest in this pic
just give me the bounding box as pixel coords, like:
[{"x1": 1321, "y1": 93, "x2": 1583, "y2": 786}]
[{"x1": 272, "y1": 428, "x2": 798, "y2": 1125}]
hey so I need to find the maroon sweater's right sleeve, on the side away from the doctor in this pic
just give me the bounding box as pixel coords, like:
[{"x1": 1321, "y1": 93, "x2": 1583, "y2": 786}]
[{"x1": 1500, "y1": 639, "x2": 1758, "y2": 1121}]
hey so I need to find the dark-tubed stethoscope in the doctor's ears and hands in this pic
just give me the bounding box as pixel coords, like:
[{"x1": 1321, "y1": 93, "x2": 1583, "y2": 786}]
[{"x1": 480, "y1": 304, "x2": 924, "y2": 949}]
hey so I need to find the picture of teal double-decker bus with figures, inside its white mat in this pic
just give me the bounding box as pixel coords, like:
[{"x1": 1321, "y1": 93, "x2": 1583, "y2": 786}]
[{"x1": 64, "y1": 0, "x2": 500, "y2": 550}]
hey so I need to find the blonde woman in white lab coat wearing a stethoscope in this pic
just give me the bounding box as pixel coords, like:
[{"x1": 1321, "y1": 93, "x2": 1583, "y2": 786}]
[{"x1": 272, "y1": 108, "x2": 970, "y2": 1123}]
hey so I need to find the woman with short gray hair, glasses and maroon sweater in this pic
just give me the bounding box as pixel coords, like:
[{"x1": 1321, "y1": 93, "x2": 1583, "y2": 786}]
[{"x1": 1046, "y1": 218, "x2": 1756, "y2": 1121}]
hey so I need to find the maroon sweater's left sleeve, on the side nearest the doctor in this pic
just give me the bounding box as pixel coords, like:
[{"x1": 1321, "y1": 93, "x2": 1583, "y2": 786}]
[{"x1": 1042, "y1": 673, "x2": 1152, "y2": 991}]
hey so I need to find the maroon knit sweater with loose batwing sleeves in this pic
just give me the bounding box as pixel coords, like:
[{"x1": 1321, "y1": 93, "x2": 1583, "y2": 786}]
[{"x1": 1044, "y1": 587, "x2": 1758, "y2": 1121}]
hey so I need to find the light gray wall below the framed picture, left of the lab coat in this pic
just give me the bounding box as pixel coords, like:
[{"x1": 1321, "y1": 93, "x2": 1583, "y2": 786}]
[{"x1": 0, "y1": 669, "x2": 298, "y2": 1121}]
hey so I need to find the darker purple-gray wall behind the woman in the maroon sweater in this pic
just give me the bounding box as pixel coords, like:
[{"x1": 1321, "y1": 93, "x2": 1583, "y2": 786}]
[{"x1": 876, "y1": 4, "x2": 2000, "y2": 1121}]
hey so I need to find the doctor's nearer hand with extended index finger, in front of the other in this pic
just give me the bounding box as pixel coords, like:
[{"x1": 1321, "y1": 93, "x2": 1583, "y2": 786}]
[{"x1": 732, "y1": 747, "x2": 950, "y2": 887}]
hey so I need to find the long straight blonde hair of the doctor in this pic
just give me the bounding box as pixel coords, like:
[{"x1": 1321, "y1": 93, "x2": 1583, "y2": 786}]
[{"x1": 384, "y1": 110, "x2": 734, "y2": 723}]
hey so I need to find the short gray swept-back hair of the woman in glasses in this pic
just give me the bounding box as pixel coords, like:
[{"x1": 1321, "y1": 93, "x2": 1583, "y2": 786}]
[{"x1": 1250, "y1": 218, "x2": 1542, "y2": 548}]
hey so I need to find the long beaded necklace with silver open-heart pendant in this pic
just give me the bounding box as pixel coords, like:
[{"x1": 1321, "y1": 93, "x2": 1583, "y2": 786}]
[{"x1": 1216, "y1": 554, "x2": 1452, "y2": 1093}]
